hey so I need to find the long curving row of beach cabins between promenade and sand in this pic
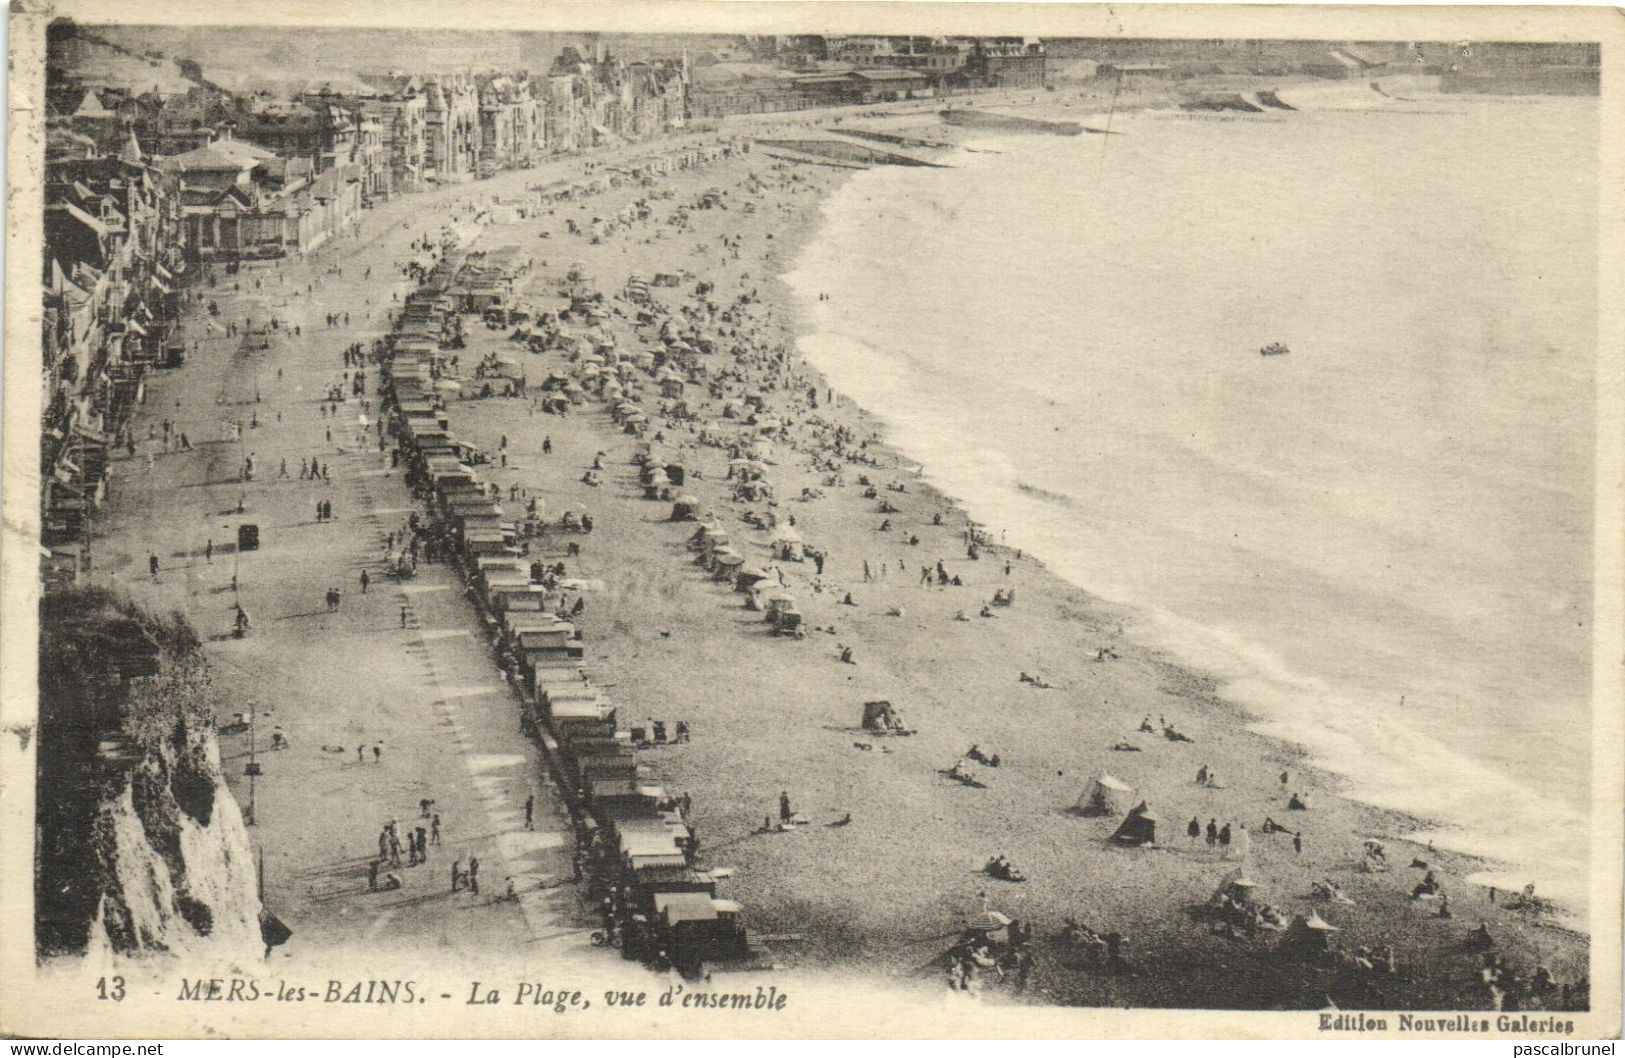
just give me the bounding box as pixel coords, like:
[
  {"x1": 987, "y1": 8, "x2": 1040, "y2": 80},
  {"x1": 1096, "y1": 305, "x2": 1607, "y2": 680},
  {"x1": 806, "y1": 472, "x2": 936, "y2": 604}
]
[{"x1": 384, "y1": 269, "x2": 770, "y2": 977}]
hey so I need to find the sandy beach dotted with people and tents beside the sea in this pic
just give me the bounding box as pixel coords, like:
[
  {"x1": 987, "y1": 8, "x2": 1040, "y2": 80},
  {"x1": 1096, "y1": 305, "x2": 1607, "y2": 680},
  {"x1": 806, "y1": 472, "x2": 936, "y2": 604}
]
[{"x1": 406, "y1": 105, "x2": 1586, "y2": 1009}]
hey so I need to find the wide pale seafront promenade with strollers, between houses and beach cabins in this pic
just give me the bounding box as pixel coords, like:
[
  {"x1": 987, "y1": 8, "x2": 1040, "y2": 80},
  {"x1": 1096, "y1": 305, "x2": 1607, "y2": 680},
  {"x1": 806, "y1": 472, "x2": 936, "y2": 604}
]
[{"x1": 93, "y1": 157, "x2": 604, "y2": 954}]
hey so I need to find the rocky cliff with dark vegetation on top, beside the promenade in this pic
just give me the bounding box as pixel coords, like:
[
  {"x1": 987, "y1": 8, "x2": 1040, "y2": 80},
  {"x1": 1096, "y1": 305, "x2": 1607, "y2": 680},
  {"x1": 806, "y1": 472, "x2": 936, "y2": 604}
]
[{"x1": 34, "y1": 588, "x2": 260, "y2": 957}]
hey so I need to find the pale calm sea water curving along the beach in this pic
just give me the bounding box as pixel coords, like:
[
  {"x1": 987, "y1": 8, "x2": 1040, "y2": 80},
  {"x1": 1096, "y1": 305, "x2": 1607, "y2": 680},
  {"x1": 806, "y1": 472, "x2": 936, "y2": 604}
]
[{"x1": 790, "y1": 96, "x2": 1597, "y2": 910}]
